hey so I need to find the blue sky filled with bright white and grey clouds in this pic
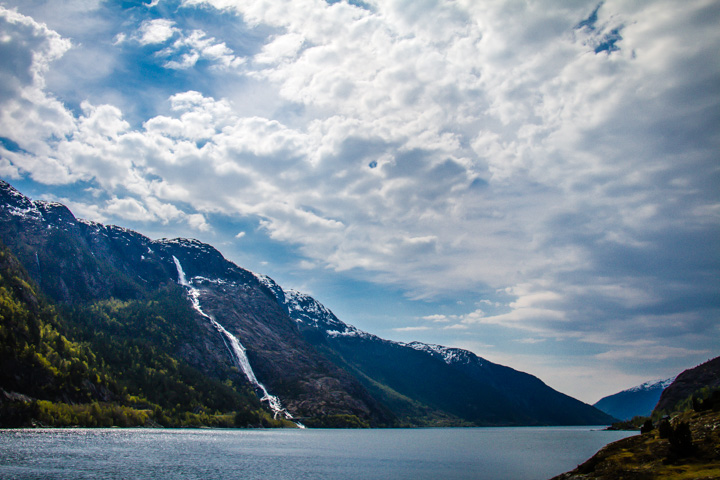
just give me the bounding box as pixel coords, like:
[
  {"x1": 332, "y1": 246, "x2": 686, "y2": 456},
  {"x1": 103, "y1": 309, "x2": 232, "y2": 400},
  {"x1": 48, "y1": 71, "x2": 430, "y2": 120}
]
[{"x1": 0, "y1": 0, "x2": 720, "y2": 403}]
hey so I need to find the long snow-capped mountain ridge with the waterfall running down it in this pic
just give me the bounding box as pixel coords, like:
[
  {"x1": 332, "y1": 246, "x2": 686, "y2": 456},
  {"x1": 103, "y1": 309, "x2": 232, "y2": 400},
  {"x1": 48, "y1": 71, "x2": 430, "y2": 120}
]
[{"x1": 0, "y1": 181, "x2": 612, "y2": 426}]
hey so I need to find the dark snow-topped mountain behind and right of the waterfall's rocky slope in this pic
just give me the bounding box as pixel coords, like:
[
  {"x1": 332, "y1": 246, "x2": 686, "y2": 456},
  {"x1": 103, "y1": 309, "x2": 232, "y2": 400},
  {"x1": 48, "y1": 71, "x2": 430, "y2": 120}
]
[{"x1": 258, "y1": 276, "x2": 612, "y2": 425}]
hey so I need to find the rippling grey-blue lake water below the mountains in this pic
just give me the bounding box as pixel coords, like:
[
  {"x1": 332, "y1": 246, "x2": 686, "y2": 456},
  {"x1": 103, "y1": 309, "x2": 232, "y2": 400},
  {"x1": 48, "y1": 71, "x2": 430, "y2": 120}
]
[{"x1": 0, "y1": 427, "x2": 631, "y2": 480}]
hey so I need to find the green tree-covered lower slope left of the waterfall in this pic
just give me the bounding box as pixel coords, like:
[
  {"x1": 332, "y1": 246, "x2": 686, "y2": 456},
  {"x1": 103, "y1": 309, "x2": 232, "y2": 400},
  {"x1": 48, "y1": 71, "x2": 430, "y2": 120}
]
[{"x1": 0, "y1": 250, "x2": 292, "y2": 427}]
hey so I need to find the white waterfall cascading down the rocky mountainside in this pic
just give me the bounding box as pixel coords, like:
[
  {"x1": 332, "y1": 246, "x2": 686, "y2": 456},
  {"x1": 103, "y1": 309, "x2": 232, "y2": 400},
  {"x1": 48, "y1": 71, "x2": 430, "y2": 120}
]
[{"x1": 173, "y1": 255, "x2": 305, "y2": 428}]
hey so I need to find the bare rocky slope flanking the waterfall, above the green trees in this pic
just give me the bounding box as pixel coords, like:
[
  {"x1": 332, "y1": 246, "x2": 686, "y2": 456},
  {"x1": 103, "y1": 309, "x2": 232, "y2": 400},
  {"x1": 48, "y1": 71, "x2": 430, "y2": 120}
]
[{"x1": 0, "y1": 182, "x2": 394, "y2": 426}]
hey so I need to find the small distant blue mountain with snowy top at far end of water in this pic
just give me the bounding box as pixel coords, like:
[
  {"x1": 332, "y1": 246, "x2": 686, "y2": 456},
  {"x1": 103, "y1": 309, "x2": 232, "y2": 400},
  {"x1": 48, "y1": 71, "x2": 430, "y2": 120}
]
[{"x1": 593, "y1": 377, "x2": 675, "y2": 420}]
